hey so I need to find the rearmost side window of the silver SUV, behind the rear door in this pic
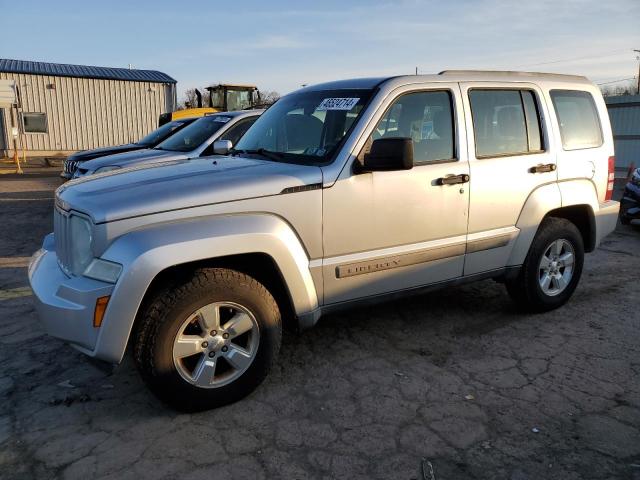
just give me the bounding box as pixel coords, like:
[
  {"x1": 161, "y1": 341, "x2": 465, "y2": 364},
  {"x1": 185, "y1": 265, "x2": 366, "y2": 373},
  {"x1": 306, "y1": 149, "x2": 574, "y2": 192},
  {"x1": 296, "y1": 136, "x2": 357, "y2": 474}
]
[{"x1": 550, "y1": 90, "x2": 602, "y2": 150}]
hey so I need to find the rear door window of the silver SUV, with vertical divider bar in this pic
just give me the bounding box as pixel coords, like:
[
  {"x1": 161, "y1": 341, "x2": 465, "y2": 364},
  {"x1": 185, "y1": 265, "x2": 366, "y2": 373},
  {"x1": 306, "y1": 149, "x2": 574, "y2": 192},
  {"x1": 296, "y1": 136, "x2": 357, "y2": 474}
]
[{"x1": 469, "y1": 89, "x2": 543, "y2": 158}]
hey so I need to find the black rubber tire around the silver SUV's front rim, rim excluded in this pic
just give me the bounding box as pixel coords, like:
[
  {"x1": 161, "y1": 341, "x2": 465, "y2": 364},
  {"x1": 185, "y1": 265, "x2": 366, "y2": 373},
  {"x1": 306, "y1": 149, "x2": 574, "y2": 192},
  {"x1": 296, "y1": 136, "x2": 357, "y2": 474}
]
[{"x1": 134, "y1": 268, "x2": 282, "y2": 412}]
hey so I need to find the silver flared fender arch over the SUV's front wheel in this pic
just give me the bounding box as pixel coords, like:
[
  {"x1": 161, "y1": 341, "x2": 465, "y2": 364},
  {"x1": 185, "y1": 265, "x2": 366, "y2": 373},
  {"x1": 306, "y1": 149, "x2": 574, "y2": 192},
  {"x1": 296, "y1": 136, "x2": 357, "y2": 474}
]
[{"x1": 96, "y1": 214, "x2": 318, "y2": 363}]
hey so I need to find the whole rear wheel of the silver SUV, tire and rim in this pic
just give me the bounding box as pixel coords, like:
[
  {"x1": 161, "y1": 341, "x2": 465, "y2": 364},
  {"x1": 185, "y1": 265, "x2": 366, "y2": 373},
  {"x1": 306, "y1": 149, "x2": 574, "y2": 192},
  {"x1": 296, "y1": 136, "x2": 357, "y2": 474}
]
[{"x1": 506, "y1": 217, "x2": 584, "y2": 312}]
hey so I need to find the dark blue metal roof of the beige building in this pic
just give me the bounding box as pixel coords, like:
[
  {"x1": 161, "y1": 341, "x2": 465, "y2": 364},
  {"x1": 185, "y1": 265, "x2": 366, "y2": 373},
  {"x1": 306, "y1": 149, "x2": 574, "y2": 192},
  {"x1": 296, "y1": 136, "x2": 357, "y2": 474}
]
[{"x1": 0, "y1": 58, "x2": 177, "y2": 83}]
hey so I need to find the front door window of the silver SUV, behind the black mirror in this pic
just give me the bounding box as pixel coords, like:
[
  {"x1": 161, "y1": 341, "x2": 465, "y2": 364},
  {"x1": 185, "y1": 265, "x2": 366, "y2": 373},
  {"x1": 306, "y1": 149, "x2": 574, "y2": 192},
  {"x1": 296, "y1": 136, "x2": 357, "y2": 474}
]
[{"x1": 371, "y1": 91, "x2": 455, "y2": 163}]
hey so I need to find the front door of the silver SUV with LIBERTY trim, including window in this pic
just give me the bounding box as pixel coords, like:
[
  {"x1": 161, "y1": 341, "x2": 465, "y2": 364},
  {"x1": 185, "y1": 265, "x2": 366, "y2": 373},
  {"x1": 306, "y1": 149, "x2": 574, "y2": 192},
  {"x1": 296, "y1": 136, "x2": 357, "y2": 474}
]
[{"x1": 322, "y1": 83, "x2": 469, "y2": 305}]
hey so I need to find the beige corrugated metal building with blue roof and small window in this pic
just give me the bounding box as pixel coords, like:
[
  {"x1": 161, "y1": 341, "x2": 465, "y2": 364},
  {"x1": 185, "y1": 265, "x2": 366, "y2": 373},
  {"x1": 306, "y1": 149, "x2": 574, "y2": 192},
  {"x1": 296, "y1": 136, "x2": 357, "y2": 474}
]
[{"x1": 0, "y1": 59, "x2": 176, "y2": 157}]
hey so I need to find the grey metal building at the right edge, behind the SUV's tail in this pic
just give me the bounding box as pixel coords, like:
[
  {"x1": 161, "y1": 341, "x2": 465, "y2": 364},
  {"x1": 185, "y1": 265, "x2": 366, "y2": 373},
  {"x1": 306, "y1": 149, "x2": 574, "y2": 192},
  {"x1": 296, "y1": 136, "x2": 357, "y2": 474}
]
[{"x1": 605, "y1": 95, "x2": 640, "y2": 173}]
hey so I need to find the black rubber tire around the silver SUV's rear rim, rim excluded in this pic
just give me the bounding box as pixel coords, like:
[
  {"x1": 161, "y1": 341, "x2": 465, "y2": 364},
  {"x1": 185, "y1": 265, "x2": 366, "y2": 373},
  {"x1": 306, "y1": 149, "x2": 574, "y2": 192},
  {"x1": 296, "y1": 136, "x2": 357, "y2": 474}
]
[{"x1": 505, "y1": 217, "x2": 584, "y2": 312}]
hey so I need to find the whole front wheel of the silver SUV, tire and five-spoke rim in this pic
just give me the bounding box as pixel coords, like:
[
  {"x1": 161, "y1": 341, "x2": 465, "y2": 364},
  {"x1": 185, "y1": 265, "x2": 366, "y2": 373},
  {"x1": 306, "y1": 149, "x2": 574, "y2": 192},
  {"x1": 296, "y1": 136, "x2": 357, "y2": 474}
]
[{"x1": 134, "y1": 268, "x2": 282, "y2": 411}]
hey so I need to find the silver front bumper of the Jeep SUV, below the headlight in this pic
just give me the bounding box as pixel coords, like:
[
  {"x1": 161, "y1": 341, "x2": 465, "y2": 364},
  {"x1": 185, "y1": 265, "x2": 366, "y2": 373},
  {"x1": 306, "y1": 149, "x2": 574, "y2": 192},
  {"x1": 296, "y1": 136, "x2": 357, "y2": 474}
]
[{"x1": 29, "y1": 234, "x2": 114, "y2": 359}]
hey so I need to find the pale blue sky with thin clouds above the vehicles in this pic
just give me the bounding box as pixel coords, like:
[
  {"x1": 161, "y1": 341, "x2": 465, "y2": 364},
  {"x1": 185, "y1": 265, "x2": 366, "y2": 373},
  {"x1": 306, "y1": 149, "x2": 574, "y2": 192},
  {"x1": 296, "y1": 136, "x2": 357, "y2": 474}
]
[{"x1": 0, "y1": 0, "x2": 640, "y2": 99}]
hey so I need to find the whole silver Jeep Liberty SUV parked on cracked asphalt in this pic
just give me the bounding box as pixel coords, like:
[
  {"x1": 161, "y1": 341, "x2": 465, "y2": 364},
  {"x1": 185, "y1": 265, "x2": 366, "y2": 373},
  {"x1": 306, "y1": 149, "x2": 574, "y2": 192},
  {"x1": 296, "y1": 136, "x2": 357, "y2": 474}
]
[{"x1": 29, "y1": 71, "x2": 619, "y2": 410}]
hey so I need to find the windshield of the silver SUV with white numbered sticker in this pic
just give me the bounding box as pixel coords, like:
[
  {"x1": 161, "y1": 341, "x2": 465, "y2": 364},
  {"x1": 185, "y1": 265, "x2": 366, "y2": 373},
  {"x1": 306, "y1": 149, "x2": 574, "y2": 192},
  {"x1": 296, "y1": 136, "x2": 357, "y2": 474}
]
[{"x1": 235, "y1": 89, "x2": 372, "y2": 164}]
